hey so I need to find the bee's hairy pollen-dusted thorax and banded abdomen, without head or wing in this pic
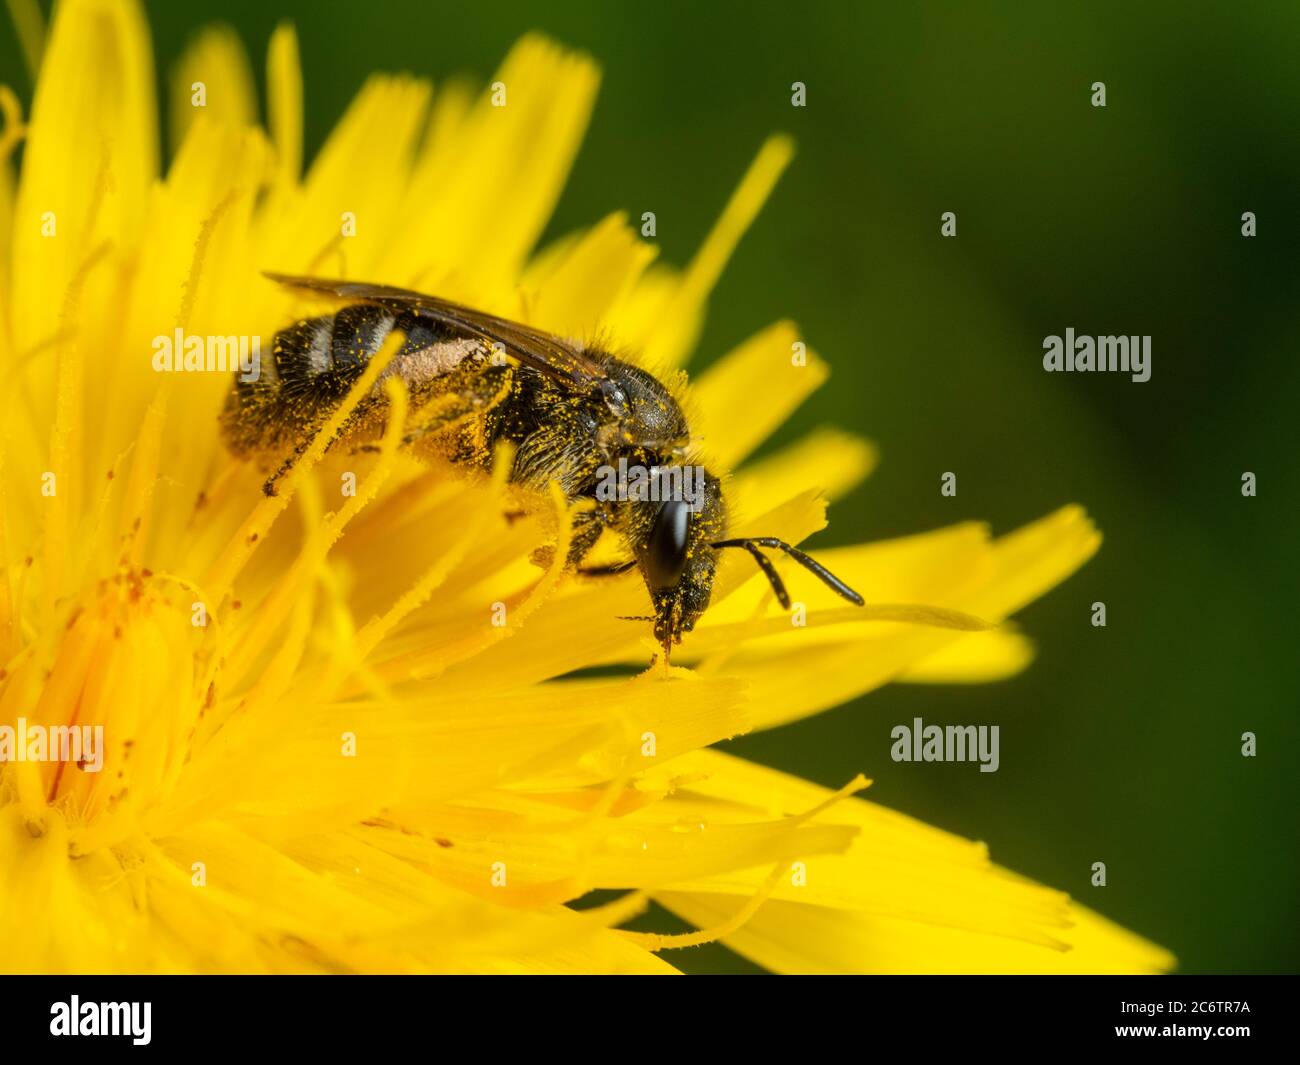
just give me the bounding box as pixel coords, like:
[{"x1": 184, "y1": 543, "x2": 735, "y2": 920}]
[{"x1": 224, "y1": 303, "x2": 688, "y2": 501}]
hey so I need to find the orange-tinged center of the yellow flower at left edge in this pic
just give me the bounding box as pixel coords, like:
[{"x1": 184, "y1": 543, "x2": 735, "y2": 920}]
[{"x1": 0, "y1": 566, "x2": 202, "y2": 853}]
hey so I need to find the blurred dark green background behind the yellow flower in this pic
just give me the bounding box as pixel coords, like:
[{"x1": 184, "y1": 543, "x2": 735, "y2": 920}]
[{"x1": 0, "y1": 0, "x2": 1300, "y2": 973}]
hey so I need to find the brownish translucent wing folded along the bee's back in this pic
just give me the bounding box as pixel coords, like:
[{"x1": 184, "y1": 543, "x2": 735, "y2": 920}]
[{"x1": 267, "y1": 272, "x2": 607, "y2": 388}]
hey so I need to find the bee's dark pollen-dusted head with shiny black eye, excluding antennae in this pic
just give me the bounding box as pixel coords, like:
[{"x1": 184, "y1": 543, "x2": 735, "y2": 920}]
[{"x1": 632, "y1": 467, "x2": 727, "y2": 655}]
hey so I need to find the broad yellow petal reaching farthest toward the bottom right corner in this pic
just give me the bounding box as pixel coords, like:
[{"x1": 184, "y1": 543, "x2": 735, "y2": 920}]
[{"x1": 655, "y1": 752, "x2": 1174, "y2": 973}]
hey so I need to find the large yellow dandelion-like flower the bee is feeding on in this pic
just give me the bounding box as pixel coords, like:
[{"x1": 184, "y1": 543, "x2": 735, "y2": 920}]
[{"x1": 0, "y1": 0, "x2": 1171, "y2": 973}]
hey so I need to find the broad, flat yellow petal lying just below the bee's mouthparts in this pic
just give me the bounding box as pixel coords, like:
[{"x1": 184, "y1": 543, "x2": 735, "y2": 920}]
[{"x1": 153, "y1": 675, "x2": 748, "y2": 832}]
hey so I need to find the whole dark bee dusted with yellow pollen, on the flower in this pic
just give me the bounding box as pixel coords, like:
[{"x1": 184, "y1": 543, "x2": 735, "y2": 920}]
[{"x1": 221, "y1": 273, "x2": 863, "y2": 658}]
